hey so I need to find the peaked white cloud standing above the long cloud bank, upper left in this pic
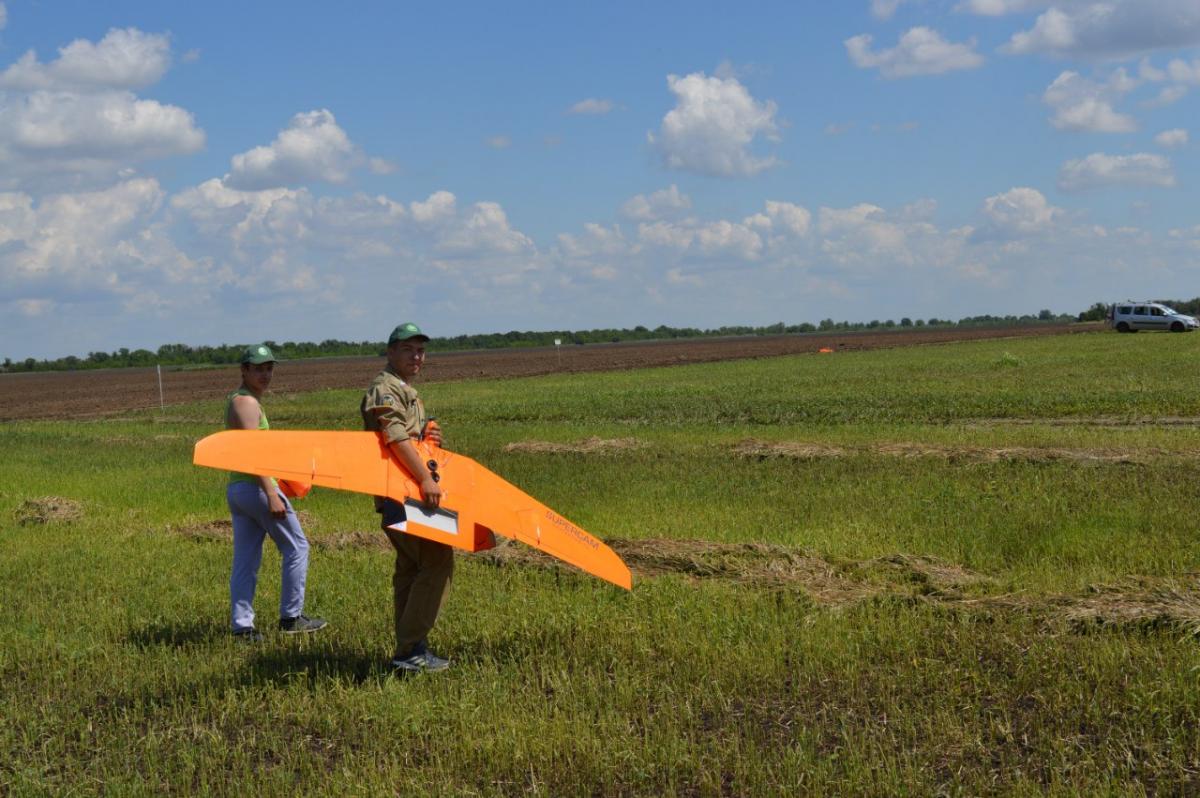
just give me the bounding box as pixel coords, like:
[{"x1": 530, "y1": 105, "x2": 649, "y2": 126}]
[{"x1": 226, "y1": 109, "x2": 366, "y2": 191}]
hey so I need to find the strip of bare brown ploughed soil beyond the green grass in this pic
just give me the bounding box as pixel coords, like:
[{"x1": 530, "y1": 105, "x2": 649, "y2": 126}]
[{"x1": 0, "y1": 324, "x2": 1103, "y2": 421}]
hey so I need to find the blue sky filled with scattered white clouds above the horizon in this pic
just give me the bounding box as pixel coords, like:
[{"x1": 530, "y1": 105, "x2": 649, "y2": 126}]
[{"x1": 0, "y1": 0, "x2": 1200, "y2": 360}]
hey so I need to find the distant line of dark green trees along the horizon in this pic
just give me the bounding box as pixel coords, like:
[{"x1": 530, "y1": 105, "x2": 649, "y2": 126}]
[{"x1": 0, "y1": 298, "x2": 1176, "y2": 373}]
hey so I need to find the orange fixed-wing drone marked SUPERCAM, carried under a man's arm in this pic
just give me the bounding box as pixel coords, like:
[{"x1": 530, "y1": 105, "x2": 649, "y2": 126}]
[{"x1": 192, "y1": 430, "x2": 632, "y2": 590}]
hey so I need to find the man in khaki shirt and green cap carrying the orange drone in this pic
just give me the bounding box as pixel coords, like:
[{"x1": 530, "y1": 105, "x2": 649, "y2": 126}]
[{"x1": 360, "y1": 322, "x2": 454, "y2": 672}]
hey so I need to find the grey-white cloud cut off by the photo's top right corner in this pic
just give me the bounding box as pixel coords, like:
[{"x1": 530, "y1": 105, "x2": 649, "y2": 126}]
[{"x1": 1002, "y1": 0, "x2": 1200, "y2": 58}]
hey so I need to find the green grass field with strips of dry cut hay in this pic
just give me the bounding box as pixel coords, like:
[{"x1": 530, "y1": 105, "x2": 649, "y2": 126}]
[{"x1": 0, "y1": 334, "x2": 1200, "y2": 796}]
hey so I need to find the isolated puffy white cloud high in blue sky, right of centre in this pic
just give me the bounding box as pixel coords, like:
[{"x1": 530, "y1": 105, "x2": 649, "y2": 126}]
[{"x1": 648, "y1": 72, "x2": 779, "y2": 178}]
